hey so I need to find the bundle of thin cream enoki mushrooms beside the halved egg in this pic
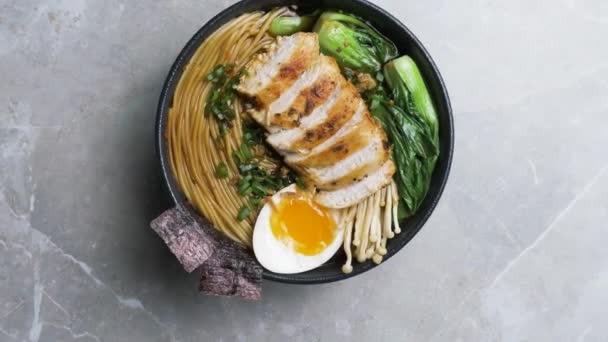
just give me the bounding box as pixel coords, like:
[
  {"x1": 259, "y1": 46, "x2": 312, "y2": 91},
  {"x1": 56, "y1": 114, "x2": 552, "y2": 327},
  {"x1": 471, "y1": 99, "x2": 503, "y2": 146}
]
[{"x1": 340, "y1": 181, "x2": 401, "y2": 273}]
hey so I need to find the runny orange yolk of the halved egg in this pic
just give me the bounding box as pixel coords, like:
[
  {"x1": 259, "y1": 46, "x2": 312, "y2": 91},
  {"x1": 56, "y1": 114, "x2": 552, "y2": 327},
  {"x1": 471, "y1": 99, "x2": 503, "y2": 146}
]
[{"x1": 270, "y1": 193, "x2": 336, "y2": 255}]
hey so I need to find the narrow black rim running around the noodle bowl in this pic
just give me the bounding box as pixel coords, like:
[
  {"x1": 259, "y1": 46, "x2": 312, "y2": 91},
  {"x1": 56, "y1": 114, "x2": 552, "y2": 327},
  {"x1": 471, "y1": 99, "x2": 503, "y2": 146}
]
[{"x1": 155, "y1": 0, "x2": 454, "y2": 284}]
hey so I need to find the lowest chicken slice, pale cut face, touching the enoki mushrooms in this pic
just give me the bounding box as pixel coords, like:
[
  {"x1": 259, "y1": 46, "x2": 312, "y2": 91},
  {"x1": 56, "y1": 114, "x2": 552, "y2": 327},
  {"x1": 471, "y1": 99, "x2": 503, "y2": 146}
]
[{"x1": 315, "y1": 159, "x2": 395, "y2": 209}]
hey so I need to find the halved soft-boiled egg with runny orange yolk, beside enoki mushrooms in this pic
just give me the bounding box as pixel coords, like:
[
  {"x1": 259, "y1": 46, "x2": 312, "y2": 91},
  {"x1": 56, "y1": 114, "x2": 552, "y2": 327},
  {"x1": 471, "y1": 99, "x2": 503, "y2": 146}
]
[{"x1": 253, "y1": 184, "x2": 343, "y2": 274}]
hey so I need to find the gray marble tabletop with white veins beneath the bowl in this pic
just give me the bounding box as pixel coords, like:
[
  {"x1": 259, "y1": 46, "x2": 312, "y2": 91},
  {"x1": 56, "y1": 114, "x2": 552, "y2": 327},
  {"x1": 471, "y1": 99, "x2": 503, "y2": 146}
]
[{"x1": 0, "y1": 0, "x2": 608, "y2": 342}]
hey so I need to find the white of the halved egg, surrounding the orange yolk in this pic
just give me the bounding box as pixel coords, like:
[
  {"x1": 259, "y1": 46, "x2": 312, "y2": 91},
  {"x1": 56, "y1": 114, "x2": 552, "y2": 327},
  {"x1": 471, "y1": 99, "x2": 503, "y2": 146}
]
[{"x1": 253, "y1": 184, "x2": 344, "y2": 274}]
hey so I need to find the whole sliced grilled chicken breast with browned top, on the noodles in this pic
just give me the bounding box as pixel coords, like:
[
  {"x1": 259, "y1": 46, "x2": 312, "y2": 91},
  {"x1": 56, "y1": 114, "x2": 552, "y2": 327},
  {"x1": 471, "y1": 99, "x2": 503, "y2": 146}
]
[{"x1": 237, "y1": 33, "x2": 395, "y2": 208}]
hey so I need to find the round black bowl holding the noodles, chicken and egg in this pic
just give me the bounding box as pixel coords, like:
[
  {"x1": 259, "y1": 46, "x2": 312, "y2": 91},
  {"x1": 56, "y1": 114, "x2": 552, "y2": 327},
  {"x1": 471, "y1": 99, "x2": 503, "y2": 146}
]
[{"x1": 155, "y1": 0, "x2": 454, "y2": 284}]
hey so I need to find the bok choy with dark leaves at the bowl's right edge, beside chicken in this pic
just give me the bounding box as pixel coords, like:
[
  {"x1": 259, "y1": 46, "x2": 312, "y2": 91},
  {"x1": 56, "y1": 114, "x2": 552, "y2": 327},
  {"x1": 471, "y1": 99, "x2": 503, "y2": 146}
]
[{"x1": 368, "y1": 56, "x2": 439, "y2": 218}]
